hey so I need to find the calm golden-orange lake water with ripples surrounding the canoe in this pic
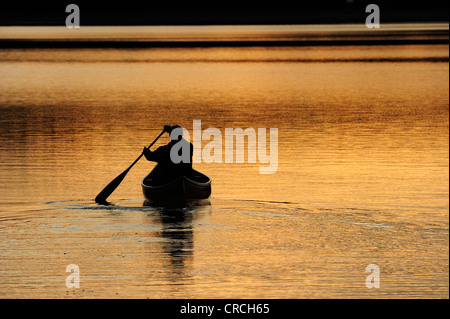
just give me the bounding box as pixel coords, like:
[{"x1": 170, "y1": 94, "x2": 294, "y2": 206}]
[{"x1": 0, "y1": 25, "x2": 449, "y2": 298}]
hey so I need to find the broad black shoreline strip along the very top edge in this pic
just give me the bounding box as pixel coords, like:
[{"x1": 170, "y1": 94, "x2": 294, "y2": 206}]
[{"x1": 0, "y1": 0, "x2": 449, "y2": 26}]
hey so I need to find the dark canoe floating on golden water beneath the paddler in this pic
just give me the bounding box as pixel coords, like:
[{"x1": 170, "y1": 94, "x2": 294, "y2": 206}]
[{"x1": 141, "y1": 165, "x2": 211, "y2": 207}]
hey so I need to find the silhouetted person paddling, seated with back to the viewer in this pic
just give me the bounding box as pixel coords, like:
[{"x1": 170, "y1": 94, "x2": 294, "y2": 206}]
[{"x1": 142, "y1": 125, "x2": 194, "y2": 181}]
